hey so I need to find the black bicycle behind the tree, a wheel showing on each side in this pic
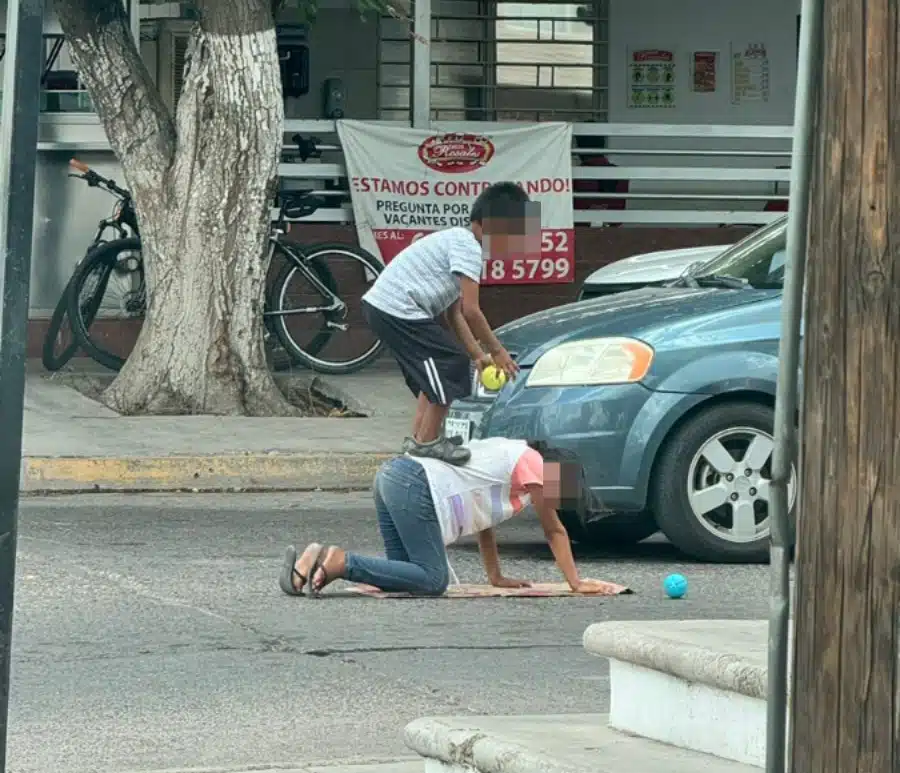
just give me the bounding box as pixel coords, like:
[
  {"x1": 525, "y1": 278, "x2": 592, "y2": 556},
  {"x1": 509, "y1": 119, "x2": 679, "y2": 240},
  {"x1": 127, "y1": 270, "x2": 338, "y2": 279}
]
[{"x1": 67, "y1": 161, "x2": 383, "y2": 375}]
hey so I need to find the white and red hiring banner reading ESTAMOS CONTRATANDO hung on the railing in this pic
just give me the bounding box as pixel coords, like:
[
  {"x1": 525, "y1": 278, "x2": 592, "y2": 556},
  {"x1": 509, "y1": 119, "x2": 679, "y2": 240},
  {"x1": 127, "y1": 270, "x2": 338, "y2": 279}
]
[{"x1": 337, "y1": 120, "x2": 575, "y2": 285}]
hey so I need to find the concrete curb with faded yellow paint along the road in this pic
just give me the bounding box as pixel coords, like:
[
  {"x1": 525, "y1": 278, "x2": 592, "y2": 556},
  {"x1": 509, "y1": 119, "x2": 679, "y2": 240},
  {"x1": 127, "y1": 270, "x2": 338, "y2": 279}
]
[{"x1": 20, "y1": 453, "x2": 395, "y2": 494}]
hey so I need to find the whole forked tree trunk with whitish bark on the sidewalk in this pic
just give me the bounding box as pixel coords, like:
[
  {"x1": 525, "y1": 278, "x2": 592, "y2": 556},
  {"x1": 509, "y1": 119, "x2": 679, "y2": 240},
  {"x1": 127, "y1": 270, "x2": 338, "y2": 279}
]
[{"x1": 56, "y1": 0, "x2": 292, "y2": 415}]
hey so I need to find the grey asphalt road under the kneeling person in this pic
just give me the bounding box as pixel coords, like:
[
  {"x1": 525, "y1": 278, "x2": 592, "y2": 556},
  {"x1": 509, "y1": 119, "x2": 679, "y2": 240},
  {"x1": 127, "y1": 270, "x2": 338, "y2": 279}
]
[{"x1": 10, "y1": 494, "x2": 768, "y2": 773}]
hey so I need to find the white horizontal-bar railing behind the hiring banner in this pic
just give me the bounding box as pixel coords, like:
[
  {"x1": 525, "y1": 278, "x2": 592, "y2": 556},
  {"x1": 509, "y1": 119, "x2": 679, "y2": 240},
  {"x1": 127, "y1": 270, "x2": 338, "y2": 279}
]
[{"x1": 281, "y1": 120, "x2": 792, "y2": 226}]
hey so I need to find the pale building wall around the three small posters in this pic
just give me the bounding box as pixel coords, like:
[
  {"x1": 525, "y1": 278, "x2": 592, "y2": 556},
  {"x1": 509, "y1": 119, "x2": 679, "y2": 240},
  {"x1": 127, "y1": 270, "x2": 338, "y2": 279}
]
[{"x1": 596, "y1": 0, "x2": 800, "y2": 211}]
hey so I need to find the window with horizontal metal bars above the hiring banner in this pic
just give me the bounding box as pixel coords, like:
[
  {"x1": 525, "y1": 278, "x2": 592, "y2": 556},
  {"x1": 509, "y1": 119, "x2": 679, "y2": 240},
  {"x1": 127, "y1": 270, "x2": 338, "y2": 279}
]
[{"x1": 376, "y1": 0, "x2": 609, "y2": 122}]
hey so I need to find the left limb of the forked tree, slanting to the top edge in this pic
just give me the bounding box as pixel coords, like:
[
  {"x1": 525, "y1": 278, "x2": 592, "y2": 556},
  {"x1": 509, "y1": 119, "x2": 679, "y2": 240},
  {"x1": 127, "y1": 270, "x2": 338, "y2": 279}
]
[{"x1": 55, "y1": 0, "x2": 176, "y2": 192}]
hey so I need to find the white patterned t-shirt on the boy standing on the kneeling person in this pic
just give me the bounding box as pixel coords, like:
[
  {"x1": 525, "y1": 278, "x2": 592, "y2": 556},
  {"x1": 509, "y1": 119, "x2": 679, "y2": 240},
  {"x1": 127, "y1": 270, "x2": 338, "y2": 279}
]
[{"x1": 363, "y1": 228, "x2": 482, "y2": 320}]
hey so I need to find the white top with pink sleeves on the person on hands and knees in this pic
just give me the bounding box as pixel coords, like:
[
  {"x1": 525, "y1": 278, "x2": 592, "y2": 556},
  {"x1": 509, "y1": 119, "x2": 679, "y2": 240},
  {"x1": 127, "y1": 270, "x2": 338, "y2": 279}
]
[{"x1": 410, "y1": 438, "x2": 543, "y2": 545}]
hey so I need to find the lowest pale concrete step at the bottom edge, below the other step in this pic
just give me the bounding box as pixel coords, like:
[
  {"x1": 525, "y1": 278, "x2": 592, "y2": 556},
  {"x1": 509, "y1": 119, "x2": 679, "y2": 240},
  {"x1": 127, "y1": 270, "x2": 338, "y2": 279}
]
[{"x1": 404, "y1": 712, "x2": 755, "y2": 773}]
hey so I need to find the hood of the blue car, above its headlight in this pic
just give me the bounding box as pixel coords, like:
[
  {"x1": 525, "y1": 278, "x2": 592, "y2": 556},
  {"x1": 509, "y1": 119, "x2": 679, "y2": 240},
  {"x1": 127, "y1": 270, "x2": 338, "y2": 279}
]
[{"x1": 496, "y1": 287, "x2": 773, "y2": 367}]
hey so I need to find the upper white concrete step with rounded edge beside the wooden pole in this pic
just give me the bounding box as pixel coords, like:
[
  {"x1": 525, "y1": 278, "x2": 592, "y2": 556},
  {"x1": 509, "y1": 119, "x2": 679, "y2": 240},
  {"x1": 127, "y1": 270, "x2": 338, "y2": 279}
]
[{"x1": 584, "y1": 620, "x2": 780, "y2": 768}]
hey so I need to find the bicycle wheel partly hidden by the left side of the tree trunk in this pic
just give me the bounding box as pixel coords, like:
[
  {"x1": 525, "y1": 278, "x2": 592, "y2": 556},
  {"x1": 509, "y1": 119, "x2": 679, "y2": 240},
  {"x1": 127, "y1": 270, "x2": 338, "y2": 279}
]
[{"x1": 68, "y1": 237, "x2": 146, "y2": 370}]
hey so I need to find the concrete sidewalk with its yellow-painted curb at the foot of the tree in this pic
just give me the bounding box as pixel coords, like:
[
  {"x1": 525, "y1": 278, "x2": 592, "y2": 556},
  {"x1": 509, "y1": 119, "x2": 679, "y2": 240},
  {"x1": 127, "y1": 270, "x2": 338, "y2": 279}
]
[{"x1": 22, "y1": 360, "x2": 415, "y2": 493}]
